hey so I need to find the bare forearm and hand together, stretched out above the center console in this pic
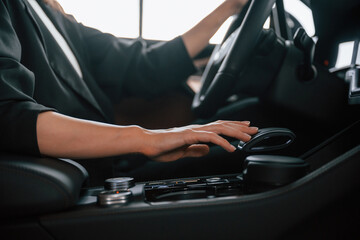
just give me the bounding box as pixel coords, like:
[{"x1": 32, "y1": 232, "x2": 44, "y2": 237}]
[{"x1": 37, "y1": 111, "x2": 257, "y2": 161}]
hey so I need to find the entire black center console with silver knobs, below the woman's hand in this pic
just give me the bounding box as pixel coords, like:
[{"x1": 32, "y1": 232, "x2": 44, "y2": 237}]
[{"x1": 1, "y1": 123, "x2": 360, "y2": 239}]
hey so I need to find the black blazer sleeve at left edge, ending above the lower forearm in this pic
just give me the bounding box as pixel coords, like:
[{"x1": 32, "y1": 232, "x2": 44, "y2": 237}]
[{"x1": 0, "y1": 1, "x2": 54, "y2": 155}]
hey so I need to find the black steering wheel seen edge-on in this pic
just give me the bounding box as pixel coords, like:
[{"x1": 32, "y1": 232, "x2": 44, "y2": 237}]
[{"x1": 192, "y1": 0, "x2": 276, "y2": 118}]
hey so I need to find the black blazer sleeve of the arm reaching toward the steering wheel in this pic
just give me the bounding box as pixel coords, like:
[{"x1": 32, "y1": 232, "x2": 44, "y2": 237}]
[{"x1": 77, "y1": 21, "x2": 196, "y2": 97}]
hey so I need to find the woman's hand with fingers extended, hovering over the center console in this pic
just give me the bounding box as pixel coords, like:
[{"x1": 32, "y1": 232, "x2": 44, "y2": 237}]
[{"x1": 140, "y1": 121, "x2": 258, "y2": 162}]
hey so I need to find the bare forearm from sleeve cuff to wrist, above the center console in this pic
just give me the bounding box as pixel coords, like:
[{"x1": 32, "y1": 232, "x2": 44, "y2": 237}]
[{"x1": 37, "y1": 112, "x2": 143, "y2": 159}]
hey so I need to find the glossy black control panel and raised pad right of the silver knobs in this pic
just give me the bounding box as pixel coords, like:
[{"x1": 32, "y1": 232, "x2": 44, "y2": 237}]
[{"x1": 144, "y1": 155, "x2": 309, "y2": 204}]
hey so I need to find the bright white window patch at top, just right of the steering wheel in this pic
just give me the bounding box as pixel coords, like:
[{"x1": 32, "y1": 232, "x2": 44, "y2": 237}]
[{"x1": 284, "y1": 0, "x2": 315, "y2": 37}]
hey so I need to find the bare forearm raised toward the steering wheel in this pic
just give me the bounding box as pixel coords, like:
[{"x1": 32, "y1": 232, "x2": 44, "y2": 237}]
[{"x1": 182, "y1": 0, "x2": 246, "y2": 57}]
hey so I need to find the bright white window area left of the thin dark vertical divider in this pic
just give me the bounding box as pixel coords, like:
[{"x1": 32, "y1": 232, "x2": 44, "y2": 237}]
[{"x1": 57, "y1": 0, "x2": 139, "y2": 38}]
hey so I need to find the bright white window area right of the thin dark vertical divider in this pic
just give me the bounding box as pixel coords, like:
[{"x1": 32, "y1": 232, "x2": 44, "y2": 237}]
[{"x1": 143, "y1": 0, "x2": 230, "y2": 43}]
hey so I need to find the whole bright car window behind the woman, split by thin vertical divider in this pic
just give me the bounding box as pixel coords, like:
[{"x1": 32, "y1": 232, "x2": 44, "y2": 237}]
[{"x1": 58, "y1": 0, "x2": 231, "y2": 43}]
